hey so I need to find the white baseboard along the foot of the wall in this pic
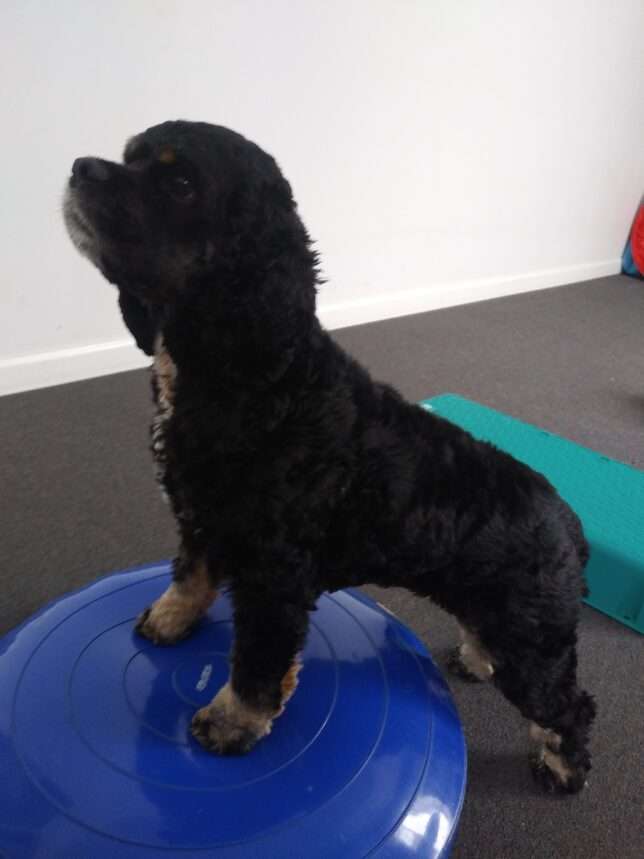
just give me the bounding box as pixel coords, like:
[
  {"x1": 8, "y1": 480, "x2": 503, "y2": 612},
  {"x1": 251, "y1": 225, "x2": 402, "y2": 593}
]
[{"x1": 0, "y1": 259, "x2": 621, "y2": 396}]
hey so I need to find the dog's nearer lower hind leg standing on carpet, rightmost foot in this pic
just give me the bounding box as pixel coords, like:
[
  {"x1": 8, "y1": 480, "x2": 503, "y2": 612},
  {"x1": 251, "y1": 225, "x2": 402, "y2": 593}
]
[{"x1": 494, "y1": 636, "x2": 595, "y2": 793}]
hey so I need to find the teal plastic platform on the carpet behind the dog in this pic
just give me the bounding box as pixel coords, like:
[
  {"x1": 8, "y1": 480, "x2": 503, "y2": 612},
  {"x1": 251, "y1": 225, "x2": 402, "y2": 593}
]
[{"x1": 421, "y1": 394, "x2": 644, "y2": 633}]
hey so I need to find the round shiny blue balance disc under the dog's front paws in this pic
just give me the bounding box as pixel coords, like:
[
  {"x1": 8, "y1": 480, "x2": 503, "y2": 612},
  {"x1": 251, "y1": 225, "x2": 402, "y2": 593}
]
[{"x1": 0, "y1": 564, "x2": 465, "y2": 859}]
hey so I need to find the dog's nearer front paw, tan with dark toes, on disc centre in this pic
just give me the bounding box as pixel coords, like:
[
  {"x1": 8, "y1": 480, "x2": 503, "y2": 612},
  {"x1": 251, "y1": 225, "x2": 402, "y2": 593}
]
[{"x1": 192, "y1": 683, "x2": 273, "y2": 755}]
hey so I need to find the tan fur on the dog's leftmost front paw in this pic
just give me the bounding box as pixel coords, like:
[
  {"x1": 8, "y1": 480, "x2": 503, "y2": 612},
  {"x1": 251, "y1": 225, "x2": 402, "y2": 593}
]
[{"x1": 143, "y1": 561, "x2": 217, "y2": 641}]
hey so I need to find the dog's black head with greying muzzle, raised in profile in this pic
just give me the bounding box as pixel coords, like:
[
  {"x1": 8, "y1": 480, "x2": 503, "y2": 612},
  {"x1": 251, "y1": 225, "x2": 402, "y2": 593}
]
[{"x1": 64, "y1": 121, "x2": 308, "y2": 351}]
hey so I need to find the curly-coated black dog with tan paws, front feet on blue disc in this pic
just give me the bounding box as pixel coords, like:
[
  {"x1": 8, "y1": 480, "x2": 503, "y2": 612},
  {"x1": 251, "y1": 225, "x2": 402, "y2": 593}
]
[{"x1": 65, "y1": 122, "x2": 595, "y2": 792}]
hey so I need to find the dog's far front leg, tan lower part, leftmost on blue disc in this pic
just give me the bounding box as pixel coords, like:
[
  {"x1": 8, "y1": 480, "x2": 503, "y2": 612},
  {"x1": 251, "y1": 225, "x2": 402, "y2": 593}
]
[{"x1": 136, "y1": 546, "x2": 217, "y2": 644}]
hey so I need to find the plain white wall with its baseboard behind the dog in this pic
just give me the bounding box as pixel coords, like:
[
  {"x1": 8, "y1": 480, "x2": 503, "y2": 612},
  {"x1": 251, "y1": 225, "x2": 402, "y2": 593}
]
[{"x1": 0, "y1": 0, "x2": 644, "y2": 392}]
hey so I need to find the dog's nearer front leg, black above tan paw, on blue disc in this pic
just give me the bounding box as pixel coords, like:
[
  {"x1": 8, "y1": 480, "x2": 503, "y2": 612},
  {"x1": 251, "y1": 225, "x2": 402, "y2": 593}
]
[{"x1": 192, "y1": 588, "x2": 309, "y2": 754}]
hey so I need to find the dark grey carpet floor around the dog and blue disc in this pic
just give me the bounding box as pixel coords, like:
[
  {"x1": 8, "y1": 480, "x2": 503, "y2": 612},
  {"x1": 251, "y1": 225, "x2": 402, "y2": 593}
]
[{"x1": 0, "y1": 277, "x2": 644, "y2": 859}]
